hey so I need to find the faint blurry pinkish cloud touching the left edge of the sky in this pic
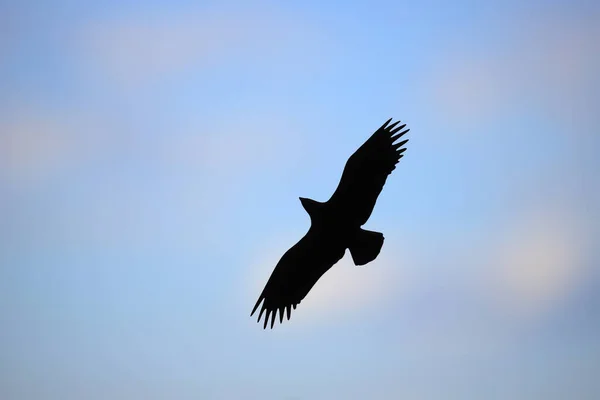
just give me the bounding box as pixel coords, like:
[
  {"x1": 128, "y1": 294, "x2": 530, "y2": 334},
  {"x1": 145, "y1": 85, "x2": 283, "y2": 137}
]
[{"x1": 0, "y1": 106, "x2": 128, "y2": 186}]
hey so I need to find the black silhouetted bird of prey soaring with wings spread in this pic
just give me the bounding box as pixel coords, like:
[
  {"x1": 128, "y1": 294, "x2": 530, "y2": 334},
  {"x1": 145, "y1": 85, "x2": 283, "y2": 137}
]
[{"x1": 250, "y1": 118, "x2": 409, "y2": 329}]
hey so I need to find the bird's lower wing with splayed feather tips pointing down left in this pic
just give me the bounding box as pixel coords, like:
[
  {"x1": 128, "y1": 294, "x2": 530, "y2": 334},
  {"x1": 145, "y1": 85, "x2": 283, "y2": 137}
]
[{"x1": 250, "y1": 228, "x2": 345, "y2": 329}]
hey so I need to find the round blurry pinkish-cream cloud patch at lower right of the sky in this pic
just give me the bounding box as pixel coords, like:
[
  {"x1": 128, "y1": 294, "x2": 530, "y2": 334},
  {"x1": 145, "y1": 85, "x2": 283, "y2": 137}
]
[{"x1": 487, "y1": 209, "x2": 589, "y2": 317}]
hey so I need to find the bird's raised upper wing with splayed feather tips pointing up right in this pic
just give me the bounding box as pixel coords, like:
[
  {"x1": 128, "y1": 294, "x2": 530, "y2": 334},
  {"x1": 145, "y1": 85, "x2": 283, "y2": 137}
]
[{"x1": 329, "y1": 118, "x2": 410, "y2": 225}]
